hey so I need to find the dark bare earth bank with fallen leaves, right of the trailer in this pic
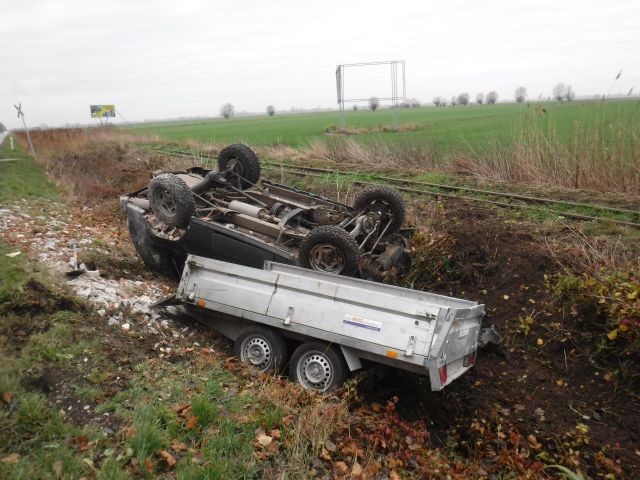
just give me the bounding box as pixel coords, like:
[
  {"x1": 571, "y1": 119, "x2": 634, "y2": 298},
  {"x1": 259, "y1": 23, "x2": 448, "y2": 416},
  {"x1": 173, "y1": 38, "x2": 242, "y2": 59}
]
[{"x1": 362, "y1": 201, "x2": 640, "y2": 477}]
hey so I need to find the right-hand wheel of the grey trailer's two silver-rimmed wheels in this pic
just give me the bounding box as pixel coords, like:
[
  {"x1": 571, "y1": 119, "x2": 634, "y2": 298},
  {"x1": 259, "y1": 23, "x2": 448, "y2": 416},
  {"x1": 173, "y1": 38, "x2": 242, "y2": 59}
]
[{"x1": 289, "y1": 342, "x2": 347, "y2": 392}]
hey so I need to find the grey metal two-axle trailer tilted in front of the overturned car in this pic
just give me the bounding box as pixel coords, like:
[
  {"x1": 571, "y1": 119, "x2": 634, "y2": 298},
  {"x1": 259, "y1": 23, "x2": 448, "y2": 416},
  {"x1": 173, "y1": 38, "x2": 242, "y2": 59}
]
[{"x1": 174, "y1": 255, "x2": 484, "y2": 391}]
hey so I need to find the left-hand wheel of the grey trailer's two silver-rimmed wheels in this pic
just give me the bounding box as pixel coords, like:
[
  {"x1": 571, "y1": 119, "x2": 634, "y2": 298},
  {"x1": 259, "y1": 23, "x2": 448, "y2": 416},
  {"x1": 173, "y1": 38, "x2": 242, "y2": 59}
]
[{"x1": 233, "y1": 327, "x2": 287, "y2": 372}]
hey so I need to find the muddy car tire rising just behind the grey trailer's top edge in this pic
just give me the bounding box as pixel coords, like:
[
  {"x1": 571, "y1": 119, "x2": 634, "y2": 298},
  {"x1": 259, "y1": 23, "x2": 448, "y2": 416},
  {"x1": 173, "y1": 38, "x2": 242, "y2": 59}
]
[{"x1": 298, "y1": 225, "x2": 360, "y2": 276}]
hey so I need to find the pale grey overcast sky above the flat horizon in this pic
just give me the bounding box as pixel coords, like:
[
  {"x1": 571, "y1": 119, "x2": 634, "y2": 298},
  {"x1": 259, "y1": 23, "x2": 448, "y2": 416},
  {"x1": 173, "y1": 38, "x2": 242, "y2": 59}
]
[{"x1": 0, "y1": 0, "x2": 640, "y2": 128}]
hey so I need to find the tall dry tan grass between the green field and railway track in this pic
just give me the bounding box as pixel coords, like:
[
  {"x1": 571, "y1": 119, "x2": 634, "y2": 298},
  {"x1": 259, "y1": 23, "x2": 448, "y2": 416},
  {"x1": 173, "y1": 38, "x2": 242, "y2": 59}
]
[{"x1": 301, "y1": 108, "x2": 640, "y2": 194}]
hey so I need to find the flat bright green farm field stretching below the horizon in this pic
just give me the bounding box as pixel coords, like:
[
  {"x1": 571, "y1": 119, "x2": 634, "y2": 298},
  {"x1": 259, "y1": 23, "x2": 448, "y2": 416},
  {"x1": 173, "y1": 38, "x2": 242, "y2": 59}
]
[{"x1": 128, "y1": 100, "x2": 640, "y2": 148}]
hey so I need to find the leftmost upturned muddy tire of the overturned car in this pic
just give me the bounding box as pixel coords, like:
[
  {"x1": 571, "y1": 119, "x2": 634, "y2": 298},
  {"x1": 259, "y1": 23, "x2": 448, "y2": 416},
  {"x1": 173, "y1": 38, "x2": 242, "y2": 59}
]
[{"x1": 147, "y1": 173, "x2": 195, "y2": 228}]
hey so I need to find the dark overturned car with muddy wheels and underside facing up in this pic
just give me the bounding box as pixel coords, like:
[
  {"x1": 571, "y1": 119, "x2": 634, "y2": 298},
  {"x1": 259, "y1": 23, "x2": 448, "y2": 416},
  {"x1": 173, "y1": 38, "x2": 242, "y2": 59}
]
[{"x1": 120, "y1": 144, "x2": 409, "y2": 278}]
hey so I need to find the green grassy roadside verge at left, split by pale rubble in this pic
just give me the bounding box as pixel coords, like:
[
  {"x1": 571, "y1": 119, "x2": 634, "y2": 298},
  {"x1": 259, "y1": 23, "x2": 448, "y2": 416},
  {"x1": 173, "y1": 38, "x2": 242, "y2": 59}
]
[{"x1": 0, "y1": 143, "x2": 346, "y2": 480}]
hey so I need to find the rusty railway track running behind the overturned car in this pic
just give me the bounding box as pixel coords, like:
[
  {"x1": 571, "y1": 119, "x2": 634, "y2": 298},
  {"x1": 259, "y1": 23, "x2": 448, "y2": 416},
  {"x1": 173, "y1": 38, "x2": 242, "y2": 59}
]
[{"x1": 148, "y1": 148, "x2": 640, "y2": 228}]
